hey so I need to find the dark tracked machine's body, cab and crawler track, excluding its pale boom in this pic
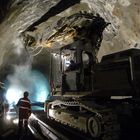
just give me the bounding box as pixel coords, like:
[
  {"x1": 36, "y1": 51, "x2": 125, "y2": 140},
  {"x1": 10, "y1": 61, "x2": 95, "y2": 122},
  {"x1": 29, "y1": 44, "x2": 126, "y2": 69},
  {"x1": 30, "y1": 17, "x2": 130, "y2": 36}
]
[{"x1": 45, "y1": 13, "x2": 140, "y2": 140}]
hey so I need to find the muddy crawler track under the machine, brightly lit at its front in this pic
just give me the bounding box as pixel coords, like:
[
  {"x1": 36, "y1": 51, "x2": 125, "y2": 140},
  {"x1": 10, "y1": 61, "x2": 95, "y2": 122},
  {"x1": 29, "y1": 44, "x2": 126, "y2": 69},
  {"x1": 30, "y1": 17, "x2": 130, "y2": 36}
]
[{"x1": 48, "y1": 100, "x2": 120, "y2": 140}]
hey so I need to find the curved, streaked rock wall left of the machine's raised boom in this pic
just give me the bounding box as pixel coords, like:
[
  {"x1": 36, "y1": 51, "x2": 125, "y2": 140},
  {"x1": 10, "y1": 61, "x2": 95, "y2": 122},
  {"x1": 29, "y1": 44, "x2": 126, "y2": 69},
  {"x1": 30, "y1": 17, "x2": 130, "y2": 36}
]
[{"x1": 0, "y1": 0, "x2": 59, "y2": 80}]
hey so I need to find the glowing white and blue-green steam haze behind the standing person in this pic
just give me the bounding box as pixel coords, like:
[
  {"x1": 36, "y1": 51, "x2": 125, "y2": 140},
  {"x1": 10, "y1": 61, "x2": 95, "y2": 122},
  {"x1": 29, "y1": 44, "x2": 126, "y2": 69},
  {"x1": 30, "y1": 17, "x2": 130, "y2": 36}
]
[{"x1": 6, "y1": 38, "x2": 49, "y2": 104}]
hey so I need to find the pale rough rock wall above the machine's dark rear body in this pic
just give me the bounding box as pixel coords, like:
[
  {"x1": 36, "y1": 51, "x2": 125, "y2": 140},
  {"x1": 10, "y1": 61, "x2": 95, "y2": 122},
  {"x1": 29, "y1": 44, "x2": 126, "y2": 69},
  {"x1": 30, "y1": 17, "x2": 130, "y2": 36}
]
[{"x1": 83, "y1": 0, "x2": 140, "y2": 57}]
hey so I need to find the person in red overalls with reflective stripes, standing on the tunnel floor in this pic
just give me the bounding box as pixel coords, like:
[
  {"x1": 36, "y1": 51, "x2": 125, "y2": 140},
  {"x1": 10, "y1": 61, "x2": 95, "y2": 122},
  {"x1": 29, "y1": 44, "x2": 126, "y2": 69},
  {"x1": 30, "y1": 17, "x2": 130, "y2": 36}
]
[{"x1": 17, "y1": 91, "x2": 31, "y2": 136}]
